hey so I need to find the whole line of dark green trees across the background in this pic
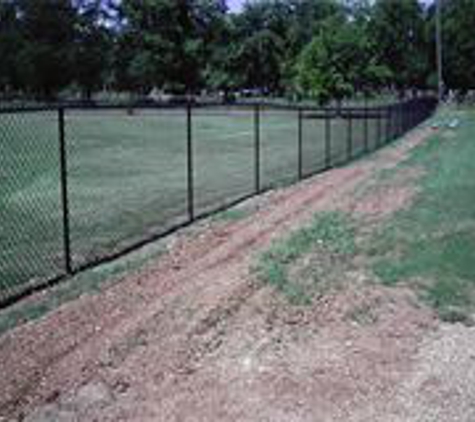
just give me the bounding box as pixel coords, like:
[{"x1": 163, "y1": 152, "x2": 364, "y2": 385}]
[{"x1": 0, "y1": 0, "x2": 475, "y2": 102}]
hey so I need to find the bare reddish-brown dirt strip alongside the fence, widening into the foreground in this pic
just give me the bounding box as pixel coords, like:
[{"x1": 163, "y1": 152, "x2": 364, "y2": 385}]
[{"x1": 0, "y1": 129, "x2": 475, "y2": 422}]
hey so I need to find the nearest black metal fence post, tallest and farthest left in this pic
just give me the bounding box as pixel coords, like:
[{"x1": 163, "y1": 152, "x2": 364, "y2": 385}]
[{"x1": 58, "y1": 107, "x2": 73, "y2": 274}]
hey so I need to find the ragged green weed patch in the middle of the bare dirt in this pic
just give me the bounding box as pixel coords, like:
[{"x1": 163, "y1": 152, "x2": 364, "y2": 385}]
[{"x1": 256, "y1": 213, "x2": 355, "y2": 304}]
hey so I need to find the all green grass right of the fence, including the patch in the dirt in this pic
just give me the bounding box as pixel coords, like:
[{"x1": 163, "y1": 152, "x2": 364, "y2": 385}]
[{"x1": 257, "y1": 109, "x2": 475, "y2": 321}]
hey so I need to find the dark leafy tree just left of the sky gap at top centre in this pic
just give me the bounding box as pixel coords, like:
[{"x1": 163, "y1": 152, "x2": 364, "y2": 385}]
[{"x1": 115, "y1": 0, "x2": 226, "y2": 92}]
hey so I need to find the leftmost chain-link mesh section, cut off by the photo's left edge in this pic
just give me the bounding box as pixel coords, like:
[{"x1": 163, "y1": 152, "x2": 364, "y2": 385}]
[{"x1": 0, "y1": 111, "x2": 64, "y2": 299}]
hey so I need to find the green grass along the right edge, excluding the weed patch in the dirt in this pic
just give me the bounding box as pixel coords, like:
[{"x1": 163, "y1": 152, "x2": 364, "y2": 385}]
[{"x1": 369, "y1": 110, "x2": 475, "y2": 319}]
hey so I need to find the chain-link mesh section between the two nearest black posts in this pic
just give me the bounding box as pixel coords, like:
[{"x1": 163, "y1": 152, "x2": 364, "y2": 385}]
[{"x1": 66, "y1": 109, "x2": 187, "y2": 268}]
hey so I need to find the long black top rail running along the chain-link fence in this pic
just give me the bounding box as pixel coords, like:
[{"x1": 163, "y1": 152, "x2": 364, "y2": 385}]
[{"x1": 0, "y1": 97, "x2": 436, "y2": 115}]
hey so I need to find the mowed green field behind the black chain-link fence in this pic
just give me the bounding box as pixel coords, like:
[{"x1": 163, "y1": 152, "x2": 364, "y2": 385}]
[{"x1": 0, "y1": 107, "x2": 384, "y2": 298}]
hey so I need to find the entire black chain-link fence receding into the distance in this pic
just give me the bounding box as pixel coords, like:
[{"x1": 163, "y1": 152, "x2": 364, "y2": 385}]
[{"x1": 0, "y1": 98, "x2": 436, "y2": 306}]
